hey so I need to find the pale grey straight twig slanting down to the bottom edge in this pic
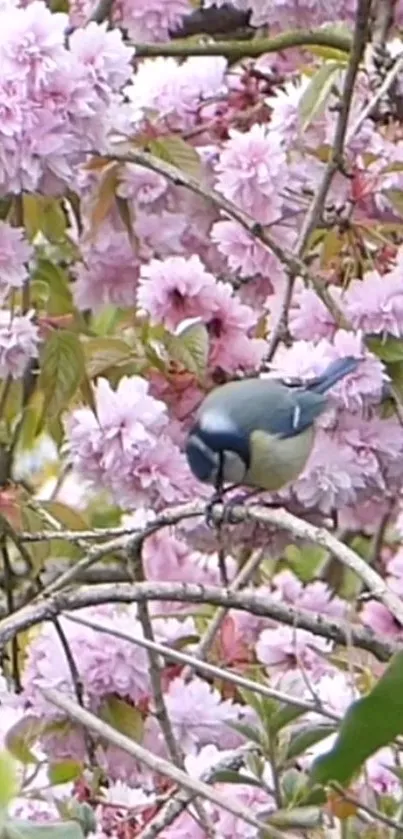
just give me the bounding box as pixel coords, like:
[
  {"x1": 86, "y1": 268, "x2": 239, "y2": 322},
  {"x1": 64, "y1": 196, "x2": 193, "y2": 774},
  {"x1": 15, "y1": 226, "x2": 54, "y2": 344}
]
[{"x1": 42, "y1": 688, "x2": 295, "y2": 839}]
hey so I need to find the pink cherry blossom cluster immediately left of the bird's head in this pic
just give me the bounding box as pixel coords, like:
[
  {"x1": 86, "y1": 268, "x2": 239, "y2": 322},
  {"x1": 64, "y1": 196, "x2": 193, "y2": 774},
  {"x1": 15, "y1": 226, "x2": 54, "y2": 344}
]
[{"x1": 66, "y1": 376, "x2": 202, "y2": 509}]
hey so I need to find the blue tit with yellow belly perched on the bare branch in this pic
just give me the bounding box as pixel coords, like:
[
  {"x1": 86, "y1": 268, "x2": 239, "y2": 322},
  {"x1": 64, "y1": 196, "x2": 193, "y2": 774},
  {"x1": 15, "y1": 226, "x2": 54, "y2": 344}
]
[{"x1": 186, "y1": 357, "x2": 359, "y2": 492}]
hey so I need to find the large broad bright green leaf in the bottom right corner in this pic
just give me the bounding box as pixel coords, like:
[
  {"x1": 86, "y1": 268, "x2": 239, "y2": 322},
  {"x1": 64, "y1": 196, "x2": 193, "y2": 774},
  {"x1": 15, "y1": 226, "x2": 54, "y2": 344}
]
[{"x1": 310, "y1": 652, "x2": 403, "y2": 786}]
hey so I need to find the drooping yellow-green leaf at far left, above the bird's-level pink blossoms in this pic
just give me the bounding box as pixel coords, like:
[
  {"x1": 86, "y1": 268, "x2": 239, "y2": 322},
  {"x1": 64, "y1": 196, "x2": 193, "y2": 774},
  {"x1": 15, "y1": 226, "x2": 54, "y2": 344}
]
[{"x1": 39, "y1": 331, "x2": 85, "y2": 420}]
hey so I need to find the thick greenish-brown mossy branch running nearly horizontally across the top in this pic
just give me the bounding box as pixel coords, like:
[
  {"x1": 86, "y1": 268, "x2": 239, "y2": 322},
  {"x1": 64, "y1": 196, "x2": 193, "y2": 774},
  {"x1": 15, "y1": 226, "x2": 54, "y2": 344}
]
[{"x1": 130, "y1": 29, "x2": 351, "y2": 61}]
